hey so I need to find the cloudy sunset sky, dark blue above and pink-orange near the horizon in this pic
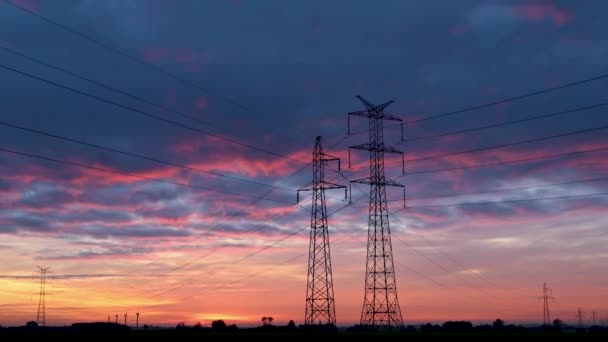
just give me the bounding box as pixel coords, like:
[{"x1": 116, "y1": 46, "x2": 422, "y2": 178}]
[{"x1": 0, "y1": 0, "x2": 608, "y2": 326}]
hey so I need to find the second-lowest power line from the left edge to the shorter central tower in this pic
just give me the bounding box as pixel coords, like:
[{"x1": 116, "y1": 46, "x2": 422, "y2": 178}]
[{"x1": 0, "y1": 121, "x2": 292, "y2": 191}]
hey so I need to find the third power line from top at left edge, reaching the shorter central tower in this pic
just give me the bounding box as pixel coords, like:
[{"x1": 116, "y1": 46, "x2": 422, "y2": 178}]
[{"x1": 0, "y1": 64, "x2": 307, "y2": 164}]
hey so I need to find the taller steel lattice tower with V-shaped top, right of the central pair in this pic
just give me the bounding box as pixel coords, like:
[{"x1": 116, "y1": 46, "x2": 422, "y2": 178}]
[{"x1": 348, "y1": 96, "x2": 405, "y2": 329}]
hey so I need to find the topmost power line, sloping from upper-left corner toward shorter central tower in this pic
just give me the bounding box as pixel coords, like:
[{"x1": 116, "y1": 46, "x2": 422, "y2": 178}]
[{"x1": 4, "y1": 0, "x2": 298, "y2": 139}]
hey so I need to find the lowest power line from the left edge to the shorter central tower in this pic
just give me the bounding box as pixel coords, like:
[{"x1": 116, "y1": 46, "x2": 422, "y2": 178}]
[{"x1": 0, "y1": 148, "x2": 293, "y2": 204}]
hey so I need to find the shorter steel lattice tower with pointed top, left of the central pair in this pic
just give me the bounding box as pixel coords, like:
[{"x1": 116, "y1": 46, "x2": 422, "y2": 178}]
[{"x1": 297, "y1": 137, "x2": 346, "y2": 325}]
